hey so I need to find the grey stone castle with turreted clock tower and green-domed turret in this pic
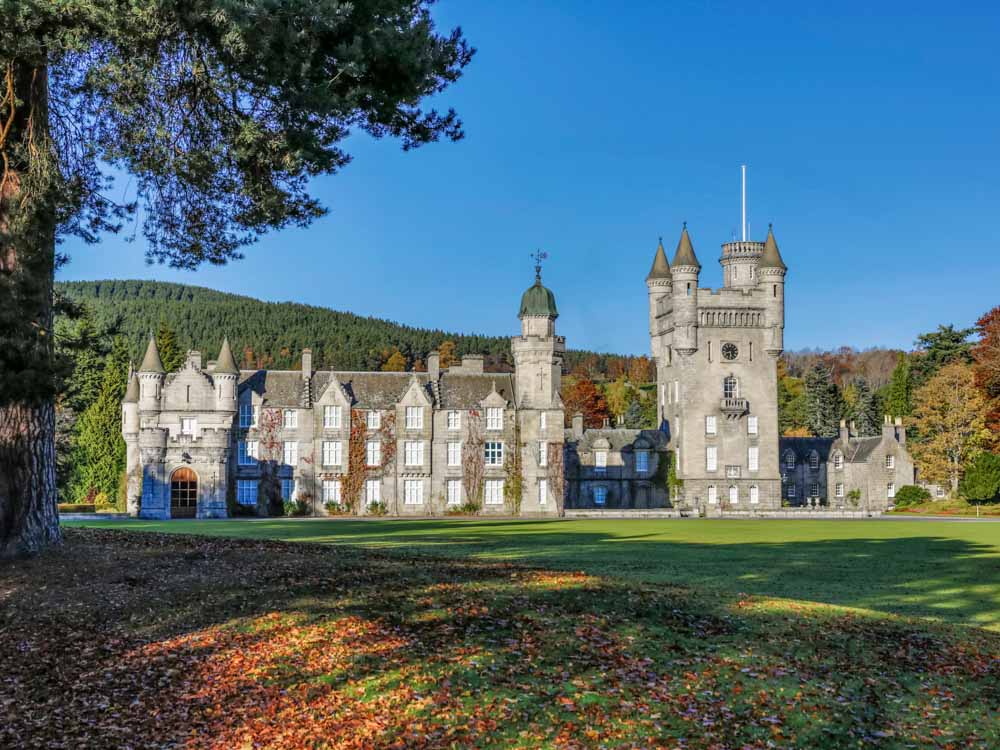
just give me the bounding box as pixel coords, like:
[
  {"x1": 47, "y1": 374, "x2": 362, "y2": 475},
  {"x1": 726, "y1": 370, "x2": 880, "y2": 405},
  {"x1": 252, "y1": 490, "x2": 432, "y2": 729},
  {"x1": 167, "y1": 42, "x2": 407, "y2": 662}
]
[{"x1": 122, "y1": 226, "x2": 913, "y2": 519}]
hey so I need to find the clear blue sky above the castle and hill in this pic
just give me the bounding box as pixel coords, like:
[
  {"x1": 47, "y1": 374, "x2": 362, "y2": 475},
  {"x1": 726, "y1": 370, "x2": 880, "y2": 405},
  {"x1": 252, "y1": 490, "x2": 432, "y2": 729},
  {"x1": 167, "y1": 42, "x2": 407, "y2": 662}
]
[{"x1": 59, "y1": 0, "x2": 1000, "y2": 353}]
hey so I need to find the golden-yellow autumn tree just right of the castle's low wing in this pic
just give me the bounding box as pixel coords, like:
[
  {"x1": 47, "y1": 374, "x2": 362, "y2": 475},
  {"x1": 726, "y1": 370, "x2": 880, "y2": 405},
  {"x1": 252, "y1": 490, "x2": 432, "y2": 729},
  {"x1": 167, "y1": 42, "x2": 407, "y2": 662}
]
[{"x1": 911, "y1": 362, "x2": 989, "y2": 492}]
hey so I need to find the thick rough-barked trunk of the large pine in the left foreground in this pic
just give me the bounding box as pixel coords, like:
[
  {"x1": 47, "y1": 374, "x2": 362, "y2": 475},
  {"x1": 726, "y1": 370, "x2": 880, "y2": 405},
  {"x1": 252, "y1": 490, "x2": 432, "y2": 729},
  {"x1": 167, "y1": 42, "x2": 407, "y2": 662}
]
[{"x1": 0, "y1": 62, "x2": 60, "y2": 559}]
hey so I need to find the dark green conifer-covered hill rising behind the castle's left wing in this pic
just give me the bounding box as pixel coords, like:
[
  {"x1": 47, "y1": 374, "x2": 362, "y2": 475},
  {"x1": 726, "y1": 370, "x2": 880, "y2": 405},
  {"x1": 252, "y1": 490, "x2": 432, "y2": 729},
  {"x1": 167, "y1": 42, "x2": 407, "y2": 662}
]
[{"x1": 56, "y1": 280, "x2": 618, "y2": 372}]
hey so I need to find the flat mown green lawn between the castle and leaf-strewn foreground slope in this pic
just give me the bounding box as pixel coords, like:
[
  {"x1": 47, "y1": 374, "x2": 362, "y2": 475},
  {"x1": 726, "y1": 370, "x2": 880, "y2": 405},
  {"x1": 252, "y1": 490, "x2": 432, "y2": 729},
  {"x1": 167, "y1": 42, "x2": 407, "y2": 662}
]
[{"x1": 67, "y1": 519, "x2": 1000, "y2": 631}]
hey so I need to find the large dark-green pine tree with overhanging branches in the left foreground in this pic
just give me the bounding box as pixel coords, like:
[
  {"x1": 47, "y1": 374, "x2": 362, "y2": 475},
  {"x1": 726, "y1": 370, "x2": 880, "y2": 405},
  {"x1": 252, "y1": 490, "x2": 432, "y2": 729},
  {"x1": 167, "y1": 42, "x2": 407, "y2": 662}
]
[{"x1": 0, "y1": 0, "x2": 473, "y2": 557}]
